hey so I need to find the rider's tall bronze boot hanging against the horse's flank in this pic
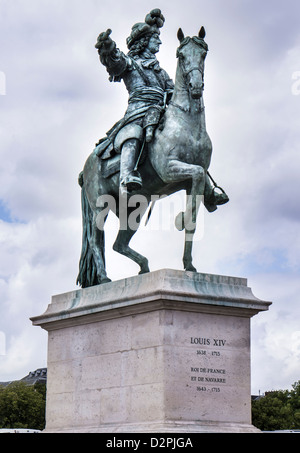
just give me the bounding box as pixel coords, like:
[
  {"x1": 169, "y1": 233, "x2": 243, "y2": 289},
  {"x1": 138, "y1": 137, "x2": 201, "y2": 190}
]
[{"x1": 120, "y1": 138, "x2": 143, "y2": 193}]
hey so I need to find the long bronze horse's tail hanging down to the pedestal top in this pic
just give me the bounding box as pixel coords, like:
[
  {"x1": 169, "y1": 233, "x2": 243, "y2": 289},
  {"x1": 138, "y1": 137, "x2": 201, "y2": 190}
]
[{"x1": 76, "y1": 172, "x2": 104, "y2": 288}]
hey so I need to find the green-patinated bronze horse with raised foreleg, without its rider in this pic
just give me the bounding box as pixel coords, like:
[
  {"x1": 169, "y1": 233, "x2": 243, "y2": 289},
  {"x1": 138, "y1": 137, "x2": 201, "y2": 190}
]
[{"x1": 77, "y1": 27, "x2": 228, "y2": 287}]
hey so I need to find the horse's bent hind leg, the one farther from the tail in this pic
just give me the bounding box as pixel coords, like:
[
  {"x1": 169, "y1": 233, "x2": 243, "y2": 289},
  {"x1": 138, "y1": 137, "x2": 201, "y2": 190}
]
[{"x1": 113, "y1": 203, "x2": 150, "y2": 274}]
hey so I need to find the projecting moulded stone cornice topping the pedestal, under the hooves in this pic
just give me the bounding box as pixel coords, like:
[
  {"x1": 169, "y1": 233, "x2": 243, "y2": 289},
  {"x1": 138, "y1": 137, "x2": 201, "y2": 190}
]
[{"x1": 31, "y1": 269, "x2": 271, "y2": 331}]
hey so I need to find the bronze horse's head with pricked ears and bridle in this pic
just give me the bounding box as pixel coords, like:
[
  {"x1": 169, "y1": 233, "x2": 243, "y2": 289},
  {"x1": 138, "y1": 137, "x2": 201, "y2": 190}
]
[{"x1": 177, "y1": 27, "x2": 208, "y2": 99}]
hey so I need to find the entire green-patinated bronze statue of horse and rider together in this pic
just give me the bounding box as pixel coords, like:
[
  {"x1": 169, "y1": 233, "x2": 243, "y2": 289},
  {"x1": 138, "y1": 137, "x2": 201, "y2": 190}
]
[{"x1": 77, "y1": 9, "x2": 229, "y2": 287}]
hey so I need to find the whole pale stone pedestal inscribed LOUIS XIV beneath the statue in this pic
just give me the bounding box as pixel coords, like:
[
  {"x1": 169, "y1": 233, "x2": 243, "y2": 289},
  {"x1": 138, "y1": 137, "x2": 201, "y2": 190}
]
[{"x1": 32, "y1": 270, "x2": 270, "y2": 433}]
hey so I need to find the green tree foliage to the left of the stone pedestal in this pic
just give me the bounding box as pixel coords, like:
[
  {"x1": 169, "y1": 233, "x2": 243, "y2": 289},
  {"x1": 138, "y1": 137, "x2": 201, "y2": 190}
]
[{"x1": 0, "y1": 382, "x2": 46, "y2": 430}]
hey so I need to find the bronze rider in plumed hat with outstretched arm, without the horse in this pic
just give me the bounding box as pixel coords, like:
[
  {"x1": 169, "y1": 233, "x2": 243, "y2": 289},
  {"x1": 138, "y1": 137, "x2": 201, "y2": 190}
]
[{"x1": 95, "y1": 9, "x2": 174, "y2": 192}]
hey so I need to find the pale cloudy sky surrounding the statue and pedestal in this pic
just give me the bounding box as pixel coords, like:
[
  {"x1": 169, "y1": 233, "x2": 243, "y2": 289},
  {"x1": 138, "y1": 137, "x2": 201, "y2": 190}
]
[{"x1": 0, "y1": 0, "x2": 300, "y2": 393}]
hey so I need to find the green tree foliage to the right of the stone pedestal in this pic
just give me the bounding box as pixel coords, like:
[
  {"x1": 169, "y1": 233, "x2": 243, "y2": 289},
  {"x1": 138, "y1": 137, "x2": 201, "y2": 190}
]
[{"x1": 252, "y1": 381, "x2": 300, "y2": 431}]
